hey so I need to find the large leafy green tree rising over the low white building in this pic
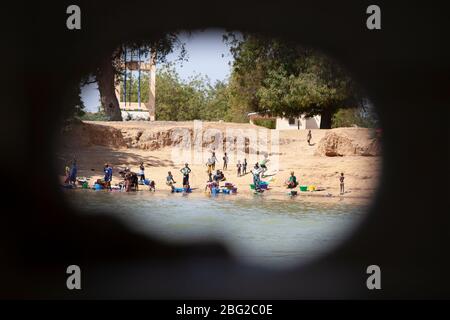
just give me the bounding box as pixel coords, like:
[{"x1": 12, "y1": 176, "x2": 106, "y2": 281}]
[{"x1": 224, "y1": 34, "x2": 357, "y2": 128}]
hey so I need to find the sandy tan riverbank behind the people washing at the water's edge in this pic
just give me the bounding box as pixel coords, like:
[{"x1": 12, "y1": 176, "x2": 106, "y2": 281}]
[{"x1": 58, "y1": 122, "x2": 381, "y2": 201}]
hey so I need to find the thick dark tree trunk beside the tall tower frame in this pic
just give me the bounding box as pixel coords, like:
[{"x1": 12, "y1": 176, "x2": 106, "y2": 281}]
[{"x1": 96, "y1": 56, "x2": 122, "y2": 121}]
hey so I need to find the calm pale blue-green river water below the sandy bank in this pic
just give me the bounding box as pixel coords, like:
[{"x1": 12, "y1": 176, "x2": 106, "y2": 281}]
[{"x1": 66, "y1": 190, "x2": 367, "y2": 267}]
